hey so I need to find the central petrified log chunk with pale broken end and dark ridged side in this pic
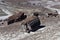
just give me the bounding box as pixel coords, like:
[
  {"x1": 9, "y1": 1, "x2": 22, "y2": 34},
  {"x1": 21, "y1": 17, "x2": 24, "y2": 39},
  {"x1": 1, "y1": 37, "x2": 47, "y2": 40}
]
[{"x1": 22, "y1": 16, "x2": 41, "y2": 32}]
